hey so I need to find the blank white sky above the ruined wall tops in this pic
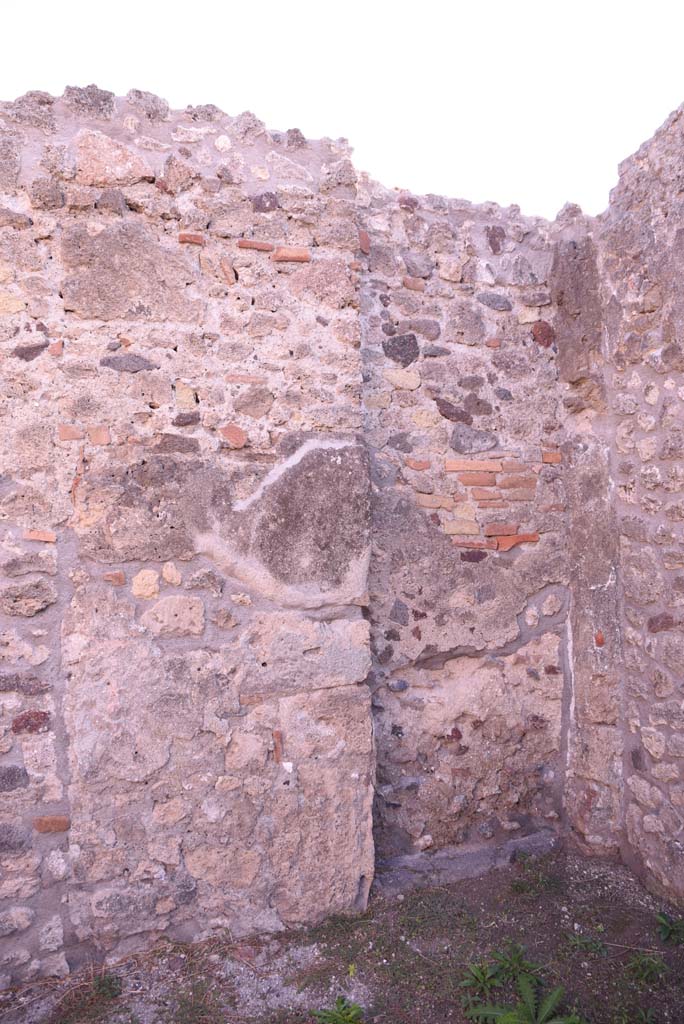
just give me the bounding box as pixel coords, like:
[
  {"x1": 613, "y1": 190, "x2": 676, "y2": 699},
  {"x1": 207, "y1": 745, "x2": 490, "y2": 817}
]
[{"x1": 0, "y1": 0, "x2": 684, "y2": 217}]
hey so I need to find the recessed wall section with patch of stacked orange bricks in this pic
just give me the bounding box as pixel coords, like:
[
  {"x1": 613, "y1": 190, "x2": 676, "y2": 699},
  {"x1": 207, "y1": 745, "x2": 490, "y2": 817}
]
[{"x1": 359, "y1": 182, "x2": 569, "y2": 856}]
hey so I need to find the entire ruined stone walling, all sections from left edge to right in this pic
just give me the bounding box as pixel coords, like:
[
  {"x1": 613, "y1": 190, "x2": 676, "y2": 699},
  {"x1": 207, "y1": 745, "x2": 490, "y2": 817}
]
[{"x1": 0, "y1": 86, "x2": 684, "y2": 982}]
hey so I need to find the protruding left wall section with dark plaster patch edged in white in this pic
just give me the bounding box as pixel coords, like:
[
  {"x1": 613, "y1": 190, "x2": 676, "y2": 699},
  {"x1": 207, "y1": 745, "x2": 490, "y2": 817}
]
[{"x1": 0, "y1": 88, "x2": 374, "y2": 978}]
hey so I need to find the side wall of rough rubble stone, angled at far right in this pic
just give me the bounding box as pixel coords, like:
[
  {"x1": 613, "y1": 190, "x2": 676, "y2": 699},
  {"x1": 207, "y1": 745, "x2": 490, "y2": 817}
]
[{"x1": 596, "y1": 103, "x2": 684, "y2": 899}]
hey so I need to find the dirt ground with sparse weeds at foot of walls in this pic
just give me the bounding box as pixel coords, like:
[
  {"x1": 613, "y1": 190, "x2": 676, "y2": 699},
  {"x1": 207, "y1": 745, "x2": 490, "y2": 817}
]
[{"x1": 0, "y1": 854, "x2": 684, "y2": 1024}]
